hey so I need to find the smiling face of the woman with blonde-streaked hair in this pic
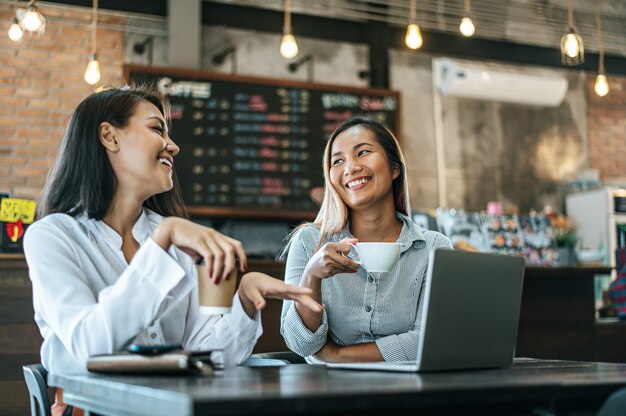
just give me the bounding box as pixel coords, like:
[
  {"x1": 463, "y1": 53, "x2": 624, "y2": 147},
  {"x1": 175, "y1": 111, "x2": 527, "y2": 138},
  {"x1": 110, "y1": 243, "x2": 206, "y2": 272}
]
[{"x1": 330, "y1": 125, "x2": 399, "y2": 210}]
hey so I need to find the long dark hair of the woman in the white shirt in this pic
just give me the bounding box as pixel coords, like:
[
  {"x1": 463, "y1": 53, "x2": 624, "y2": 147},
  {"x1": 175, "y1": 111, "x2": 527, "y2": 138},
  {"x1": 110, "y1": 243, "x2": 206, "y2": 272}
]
[{"x1": 38, "y1": 86, "x2": 187, "y2": 220}]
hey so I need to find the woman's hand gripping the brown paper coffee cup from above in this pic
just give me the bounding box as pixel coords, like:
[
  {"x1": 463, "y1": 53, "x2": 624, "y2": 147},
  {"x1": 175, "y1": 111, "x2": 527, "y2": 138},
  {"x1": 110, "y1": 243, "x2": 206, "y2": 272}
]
[{"x1": 152, "y1": 217, "x2": 247, "y2": 284}]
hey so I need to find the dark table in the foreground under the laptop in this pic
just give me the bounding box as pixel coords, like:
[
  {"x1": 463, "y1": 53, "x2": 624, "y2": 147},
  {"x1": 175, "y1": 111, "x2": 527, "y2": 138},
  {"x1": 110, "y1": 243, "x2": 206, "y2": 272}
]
[{"x1": 48, "y1": 359, "x2": 626, "y2": 416}]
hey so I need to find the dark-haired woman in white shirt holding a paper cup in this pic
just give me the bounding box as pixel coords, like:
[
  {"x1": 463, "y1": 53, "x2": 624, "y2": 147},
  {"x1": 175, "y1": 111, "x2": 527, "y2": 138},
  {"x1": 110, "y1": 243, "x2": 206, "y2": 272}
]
[{"x1": 24, "y1": 88, "x2": 322, "y2": 392}]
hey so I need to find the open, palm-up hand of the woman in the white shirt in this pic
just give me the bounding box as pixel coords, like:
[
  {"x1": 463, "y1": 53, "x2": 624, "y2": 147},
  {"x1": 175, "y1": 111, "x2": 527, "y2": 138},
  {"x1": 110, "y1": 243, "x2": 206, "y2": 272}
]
[{"x1": 237, "y1": 272, "x2": 324, "y2": 318}]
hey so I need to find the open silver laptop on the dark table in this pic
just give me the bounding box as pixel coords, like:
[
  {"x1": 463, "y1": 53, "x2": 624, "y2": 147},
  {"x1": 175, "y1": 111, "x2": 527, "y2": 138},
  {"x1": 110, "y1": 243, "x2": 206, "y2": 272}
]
[{"x1": 327, "y1": 249, "x2": 524, "y2": 372}]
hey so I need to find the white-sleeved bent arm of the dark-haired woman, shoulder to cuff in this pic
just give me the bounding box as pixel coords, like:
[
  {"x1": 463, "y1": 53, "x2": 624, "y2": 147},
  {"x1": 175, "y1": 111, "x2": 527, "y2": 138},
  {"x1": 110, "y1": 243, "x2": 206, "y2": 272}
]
[{"x1": 24, "y1": 219, "x2": 193, "y2": 363}]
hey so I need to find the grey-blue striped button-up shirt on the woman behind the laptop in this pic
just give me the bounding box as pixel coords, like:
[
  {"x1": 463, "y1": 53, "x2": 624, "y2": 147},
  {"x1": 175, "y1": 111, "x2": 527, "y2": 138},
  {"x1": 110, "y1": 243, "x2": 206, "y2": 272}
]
[{"x1": 280, "y1": 213, "x2": 452, "y2": 361}]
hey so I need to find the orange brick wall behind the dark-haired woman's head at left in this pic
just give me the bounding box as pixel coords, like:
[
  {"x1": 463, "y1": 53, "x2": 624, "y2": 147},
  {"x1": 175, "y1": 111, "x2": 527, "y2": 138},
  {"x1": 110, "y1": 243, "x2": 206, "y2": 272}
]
[{"x1": 0, "y1": 2, "x2": 124, "y2": 198}]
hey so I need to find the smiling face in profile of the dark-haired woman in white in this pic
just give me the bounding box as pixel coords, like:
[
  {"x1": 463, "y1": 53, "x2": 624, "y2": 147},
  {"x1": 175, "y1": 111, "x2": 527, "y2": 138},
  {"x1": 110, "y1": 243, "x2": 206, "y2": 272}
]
[{"x1": 107, "y1": 100, "x2": 180, "y2": 200}]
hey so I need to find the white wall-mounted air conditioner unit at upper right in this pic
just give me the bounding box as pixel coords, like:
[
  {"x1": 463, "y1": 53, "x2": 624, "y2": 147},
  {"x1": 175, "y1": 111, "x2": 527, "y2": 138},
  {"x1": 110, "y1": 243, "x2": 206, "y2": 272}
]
[{"x1": 433, "y1": 59, "x2": 567, "y2": 107}]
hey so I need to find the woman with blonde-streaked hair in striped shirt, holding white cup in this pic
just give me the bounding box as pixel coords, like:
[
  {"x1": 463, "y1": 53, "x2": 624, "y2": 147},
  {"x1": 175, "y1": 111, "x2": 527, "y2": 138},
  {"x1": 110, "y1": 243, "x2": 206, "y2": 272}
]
[{"x1": 281, "y1": 117, "x2": 451, "y2": 362}]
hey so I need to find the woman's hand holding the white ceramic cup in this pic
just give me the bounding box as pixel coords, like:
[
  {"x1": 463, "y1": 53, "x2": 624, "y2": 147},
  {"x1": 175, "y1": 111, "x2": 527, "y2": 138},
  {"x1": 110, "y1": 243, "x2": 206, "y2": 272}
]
[{"x1": 304, "y1": 238, "x2": 359, "y2": 279}]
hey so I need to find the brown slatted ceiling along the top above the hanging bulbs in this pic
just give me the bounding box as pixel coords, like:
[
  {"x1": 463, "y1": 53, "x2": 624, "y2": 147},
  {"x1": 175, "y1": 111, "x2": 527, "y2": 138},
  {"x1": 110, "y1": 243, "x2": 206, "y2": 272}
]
[{"x1": 8, "y1": 0, "x2": 626, "y2": 58}]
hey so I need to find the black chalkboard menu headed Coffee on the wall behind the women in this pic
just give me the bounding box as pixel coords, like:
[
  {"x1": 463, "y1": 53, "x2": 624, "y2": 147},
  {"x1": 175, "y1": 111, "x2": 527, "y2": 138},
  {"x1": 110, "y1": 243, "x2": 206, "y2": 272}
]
[{"x1": 124, "y1": 66, "x2": 399, "y2": 219}]
